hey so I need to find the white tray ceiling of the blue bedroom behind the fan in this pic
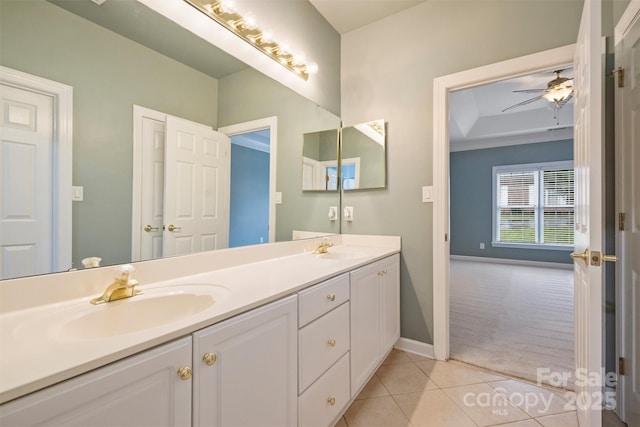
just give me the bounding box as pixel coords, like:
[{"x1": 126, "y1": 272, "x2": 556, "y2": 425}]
[{"x1": 449, "y1": 67, "x2": 573, "y2": 151}]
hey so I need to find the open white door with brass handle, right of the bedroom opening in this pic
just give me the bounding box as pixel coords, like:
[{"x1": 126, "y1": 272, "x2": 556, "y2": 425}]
[{"x1": 572, "y1": 0, "x2": 604, "y2": 426}]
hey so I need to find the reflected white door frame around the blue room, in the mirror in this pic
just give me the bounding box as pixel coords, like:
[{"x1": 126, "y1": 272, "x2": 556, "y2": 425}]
[{"x1": 218, "y1": 116, "x2": 278, "y2": 243}]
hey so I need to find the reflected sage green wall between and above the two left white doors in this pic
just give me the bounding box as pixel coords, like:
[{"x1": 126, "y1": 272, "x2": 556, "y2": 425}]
[{"x1": 0, "y1": 0, "x2": 218, "y2": 267}]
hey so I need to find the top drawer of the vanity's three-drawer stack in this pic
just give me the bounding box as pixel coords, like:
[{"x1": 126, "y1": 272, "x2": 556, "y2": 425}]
[{"x1": 298, "y1": 273, "x2": 349, "y2": 327}]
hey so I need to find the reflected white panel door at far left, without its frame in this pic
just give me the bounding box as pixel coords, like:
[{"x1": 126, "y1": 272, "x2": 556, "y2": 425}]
[{"x1": 0, "y1": 84, "x2": 57, "y2": 279}]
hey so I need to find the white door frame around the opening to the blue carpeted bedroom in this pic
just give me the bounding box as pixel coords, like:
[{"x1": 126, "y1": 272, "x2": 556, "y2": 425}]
[{"x1": 433, "y1": 44, "x2": 575, "y2": 360}]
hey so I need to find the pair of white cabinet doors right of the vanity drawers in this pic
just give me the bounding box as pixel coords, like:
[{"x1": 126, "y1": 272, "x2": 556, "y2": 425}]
[{"x1": 350, "y1": 254, "x2": 400, "y2": 397}]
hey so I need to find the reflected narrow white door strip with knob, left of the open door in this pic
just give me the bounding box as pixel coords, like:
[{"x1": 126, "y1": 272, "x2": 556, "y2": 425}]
[{"x1": 140, "y1": 117, "x2": 165, "y2": 260}]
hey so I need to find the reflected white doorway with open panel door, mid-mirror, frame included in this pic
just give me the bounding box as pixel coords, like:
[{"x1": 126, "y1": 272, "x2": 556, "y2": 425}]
[{"x1": 132, "y1": 106, "x2": 230, "y2": 260}]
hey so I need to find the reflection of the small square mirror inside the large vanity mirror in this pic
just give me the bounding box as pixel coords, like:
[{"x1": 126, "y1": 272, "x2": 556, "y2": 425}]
[{"x1": 302, "y1": 129, "x2": 340, "y2": 191}]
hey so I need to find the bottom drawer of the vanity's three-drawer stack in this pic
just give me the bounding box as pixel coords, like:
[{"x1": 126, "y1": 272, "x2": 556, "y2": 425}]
[{"x1": 298, "y1": 353, "x2": 351, "y2": 427}]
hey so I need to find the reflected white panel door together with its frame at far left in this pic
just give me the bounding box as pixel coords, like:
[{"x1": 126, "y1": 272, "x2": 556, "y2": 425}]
[{"x1": 0, "y1": 67, "x2": 72, "y2": 279}]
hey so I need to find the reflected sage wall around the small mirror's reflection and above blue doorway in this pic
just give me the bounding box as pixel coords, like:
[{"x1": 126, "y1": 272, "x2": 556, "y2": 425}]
[{"x1": 218, "y1": 69, "x2": 340, "y2": 241}]
